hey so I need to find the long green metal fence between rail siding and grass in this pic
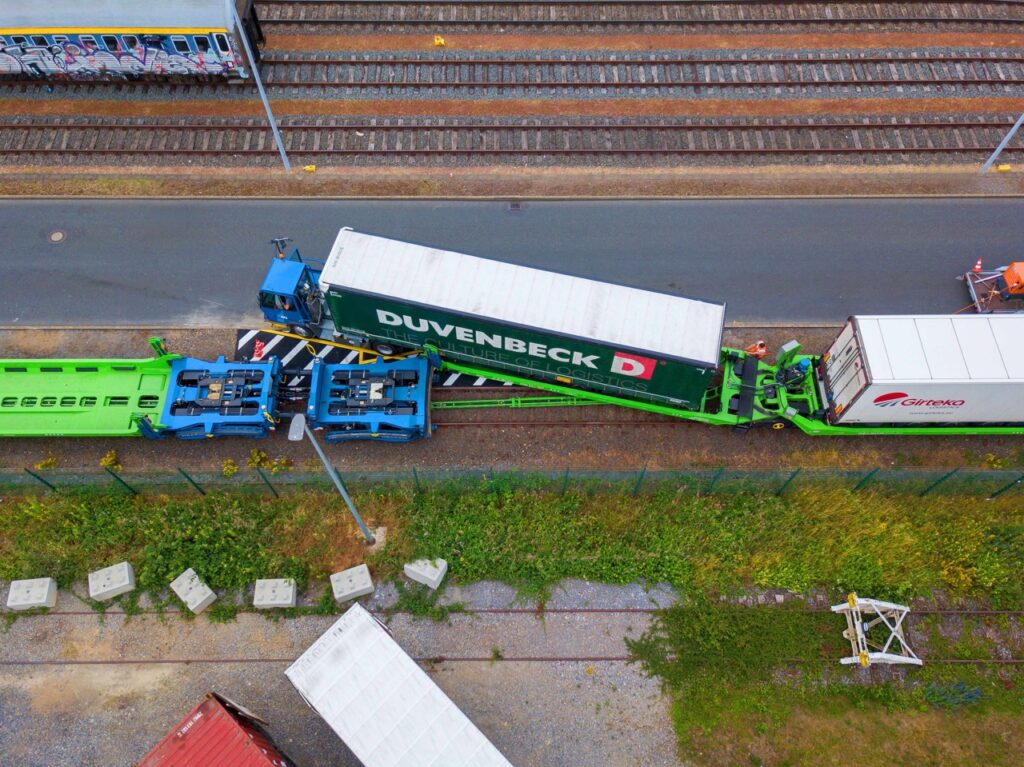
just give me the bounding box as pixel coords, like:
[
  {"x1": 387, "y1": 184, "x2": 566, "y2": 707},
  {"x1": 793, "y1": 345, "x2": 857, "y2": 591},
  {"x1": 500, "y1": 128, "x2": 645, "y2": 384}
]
[{"x1": 0, "y1": 467, "x2": 1024, "y2": 499}]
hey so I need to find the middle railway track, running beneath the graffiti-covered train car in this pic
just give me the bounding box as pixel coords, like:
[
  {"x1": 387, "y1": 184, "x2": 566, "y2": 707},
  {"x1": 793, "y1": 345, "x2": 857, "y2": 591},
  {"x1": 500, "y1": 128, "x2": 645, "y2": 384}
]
[{"x1": 0, "y1": 50, "x2": 1024, "y2": 99}]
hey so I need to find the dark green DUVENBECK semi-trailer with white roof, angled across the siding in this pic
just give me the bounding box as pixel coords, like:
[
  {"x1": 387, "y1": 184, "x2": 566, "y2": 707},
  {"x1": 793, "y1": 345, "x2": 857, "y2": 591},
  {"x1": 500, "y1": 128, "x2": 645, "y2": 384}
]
[{"x1": 321, "y1": 228, "x2": 725, "y2": 410}]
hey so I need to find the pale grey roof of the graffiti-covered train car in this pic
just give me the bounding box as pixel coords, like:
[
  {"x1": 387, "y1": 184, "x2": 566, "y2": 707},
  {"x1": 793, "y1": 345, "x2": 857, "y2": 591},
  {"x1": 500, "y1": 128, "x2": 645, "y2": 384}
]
[{"x1": 0, "y1": 0, "x2": 234, "y2": 31}]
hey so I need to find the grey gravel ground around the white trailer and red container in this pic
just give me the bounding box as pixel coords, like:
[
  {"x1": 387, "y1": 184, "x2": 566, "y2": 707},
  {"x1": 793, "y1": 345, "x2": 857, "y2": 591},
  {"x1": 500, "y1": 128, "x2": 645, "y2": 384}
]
[{"x1": 0, "y1": 583, "x2": 678, "y2": 767}]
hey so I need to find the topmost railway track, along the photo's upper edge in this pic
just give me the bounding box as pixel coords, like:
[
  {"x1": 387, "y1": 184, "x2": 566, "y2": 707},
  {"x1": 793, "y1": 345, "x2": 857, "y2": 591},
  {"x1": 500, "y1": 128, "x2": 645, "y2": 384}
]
[{"x1": 258, "y1": 0, "x2": 1024, "y2": 34}]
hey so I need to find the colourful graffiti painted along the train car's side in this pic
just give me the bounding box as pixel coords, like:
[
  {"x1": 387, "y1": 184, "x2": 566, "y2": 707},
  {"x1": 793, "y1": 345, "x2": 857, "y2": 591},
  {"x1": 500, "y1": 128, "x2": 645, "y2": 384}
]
[{"x1": 0, "y1": 38, "x2": 245, "y2": 80}]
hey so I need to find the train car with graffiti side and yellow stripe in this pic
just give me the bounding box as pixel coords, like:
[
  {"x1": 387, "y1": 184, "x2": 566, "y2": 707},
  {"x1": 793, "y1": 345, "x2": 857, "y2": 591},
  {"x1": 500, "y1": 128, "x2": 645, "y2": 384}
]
[{"x1": 0, "y1": 0, "x2": 263, "y2": 81}]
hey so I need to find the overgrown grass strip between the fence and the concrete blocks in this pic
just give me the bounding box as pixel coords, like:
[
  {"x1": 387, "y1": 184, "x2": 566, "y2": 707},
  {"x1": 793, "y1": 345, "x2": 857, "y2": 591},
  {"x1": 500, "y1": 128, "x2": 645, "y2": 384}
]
[{"x1": 0, "y1": 477, "x2": 1024, "y2": 606}]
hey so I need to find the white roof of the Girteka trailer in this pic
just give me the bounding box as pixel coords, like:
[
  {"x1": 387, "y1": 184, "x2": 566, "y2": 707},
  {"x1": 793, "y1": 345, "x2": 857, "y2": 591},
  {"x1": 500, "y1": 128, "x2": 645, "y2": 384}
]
[{"x1": 854, "y1": 314, "x2": 1024, "y2": 382}]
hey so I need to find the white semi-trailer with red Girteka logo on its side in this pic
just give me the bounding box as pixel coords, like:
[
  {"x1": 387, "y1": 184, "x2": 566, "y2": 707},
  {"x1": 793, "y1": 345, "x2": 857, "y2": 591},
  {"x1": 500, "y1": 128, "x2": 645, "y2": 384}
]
[{"x1": 819, "y1": 314, "x2": 1024, "y2": 425}]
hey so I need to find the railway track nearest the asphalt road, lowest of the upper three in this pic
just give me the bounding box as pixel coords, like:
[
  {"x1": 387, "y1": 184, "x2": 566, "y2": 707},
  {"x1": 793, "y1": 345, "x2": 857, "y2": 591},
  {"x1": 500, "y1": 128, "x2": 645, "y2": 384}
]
[{"x1": 0, "y1": 115, "x2": 1024, "y2": 165}]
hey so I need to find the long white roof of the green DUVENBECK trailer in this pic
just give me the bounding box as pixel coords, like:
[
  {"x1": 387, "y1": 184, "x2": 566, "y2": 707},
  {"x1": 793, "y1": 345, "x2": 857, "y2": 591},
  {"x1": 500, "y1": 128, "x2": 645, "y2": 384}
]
[{"x1": 321, "y1": 228, "x2": 725, "y2": 366}]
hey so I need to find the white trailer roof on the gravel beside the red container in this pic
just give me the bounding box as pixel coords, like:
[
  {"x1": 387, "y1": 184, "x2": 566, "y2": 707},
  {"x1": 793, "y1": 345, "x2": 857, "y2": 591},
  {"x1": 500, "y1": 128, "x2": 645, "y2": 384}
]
[{"x1": 285, "y1": 604, "x2": 512, "y2": 767}]
